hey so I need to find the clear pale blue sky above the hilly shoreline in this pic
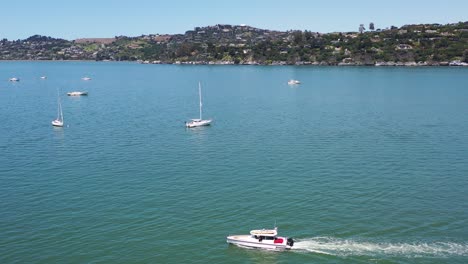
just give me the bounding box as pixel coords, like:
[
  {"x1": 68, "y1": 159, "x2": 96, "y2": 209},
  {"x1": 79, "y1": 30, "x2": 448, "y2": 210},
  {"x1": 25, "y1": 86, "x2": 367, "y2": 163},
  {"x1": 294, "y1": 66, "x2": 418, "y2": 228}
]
[{"x1": 0, "y1": 0, "x2": 468, "y2": 40}]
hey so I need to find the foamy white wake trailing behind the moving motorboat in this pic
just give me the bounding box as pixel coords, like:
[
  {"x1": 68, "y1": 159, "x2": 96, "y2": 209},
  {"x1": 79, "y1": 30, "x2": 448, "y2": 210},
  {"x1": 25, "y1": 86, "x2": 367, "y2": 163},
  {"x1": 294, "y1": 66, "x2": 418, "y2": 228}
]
[{"x1": 294, "y1": 237, "x2": 468, "y2": 257}]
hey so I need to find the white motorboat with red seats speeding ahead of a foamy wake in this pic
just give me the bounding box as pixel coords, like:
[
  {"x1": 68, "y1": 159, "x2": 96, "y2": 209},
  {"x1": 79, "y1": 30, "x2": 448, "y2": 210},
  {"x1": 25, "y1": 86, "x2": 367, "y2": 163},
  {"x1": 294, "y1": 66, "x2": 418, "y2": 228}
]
[{"x1": 226, "y1": 227, "x2": 294, "y2": 250}]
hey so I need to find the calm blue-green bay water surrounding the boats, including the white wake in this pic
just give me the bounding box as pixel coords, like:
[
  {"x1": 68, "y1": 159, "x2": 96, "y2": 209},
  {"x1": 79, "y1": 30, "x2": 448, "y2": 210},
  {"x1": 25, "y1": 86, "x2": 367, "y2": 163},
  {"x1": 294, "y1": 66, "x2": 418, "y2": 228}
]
[{"x1": 0, "y1": 62, "x2": 468, "y2": 263}]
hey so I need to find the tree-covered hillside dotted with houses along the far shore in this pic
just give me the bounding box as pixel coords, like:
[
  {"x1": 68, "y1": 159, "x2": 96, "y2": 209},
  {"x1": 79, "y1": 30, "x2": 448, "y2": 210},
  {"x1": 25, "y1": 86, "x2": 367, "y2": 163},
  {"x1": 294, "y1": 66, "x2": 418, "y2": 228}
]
[{"x1": 0, "y1": 22, "x2": 468, "y2": 65}]
